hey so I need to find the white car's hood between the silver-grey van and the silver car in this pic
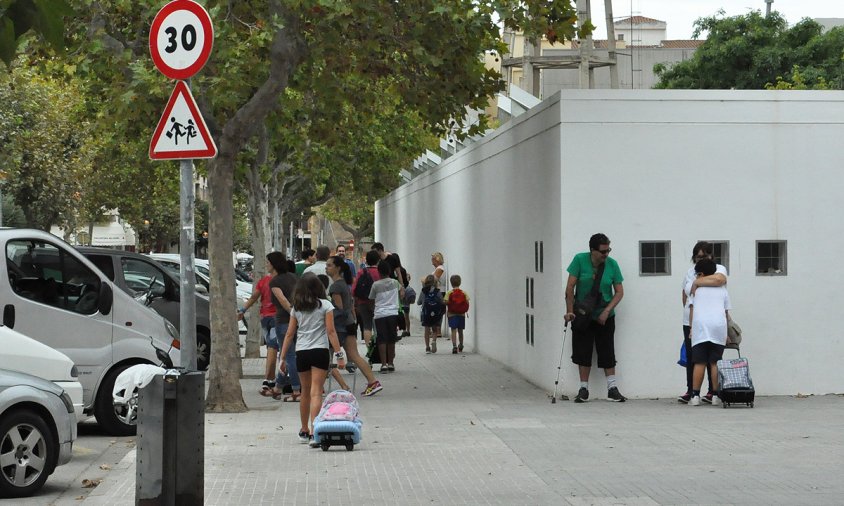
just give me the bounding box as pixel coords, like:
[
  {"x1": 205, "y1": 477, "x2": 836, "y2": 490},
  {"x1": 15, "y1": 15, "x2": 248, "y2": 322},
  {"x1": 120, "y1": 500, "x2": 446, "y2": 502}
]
[{"x1": 0, "y1": 326, "x2": 87, "y2": 422}]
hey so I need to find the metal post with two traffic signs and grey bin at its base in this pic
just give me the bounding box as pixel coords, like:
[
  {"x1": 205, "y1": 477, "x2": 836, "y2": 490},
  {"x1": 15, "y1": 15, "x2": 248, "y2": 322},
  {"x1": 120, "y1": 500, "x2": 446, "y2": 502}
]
[{"x1": 142, "y1": 0, "x2": 217, "y2": 506}]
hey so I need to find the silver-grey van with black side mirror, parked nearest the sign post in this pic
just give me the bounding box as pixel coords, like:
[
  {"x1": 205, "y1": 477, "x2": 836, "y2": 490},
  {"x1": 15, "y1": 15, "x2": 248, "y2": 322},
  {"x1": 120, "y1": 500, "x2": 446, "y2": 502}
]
[{"x1": 0, "y1": 228, "x2": 180, "y2": 435}]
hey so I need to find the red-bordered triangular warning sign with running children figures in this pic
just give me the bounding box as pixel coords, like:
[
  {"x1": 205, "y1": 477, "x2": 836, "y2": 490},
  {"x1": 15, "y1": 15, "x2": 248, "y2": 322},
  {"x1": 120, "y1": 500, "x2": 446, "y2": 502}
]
[{"x1": 149, "y1": 81, "x2": 217, "y2": 160}]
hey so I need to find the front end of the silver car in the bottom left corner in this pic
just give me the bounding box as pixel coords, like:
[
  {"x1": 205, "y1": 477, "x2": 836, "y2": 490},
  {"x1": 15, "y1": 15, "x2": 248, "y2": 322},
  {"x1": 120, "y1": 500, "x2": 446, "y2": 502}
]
[{"x1": 0, "y1": 370, "x2": 76, "y2": 497}]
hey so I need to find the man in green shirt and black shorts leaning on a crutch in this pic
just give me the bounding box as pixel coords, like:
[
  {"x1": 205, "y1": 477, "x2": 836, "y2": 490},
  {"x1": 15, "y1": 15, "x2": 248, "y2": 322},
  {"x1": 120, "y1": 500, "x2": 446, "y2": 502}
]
[{"x1": 564, "y1": 234, "x2": 627, "y2": 402}]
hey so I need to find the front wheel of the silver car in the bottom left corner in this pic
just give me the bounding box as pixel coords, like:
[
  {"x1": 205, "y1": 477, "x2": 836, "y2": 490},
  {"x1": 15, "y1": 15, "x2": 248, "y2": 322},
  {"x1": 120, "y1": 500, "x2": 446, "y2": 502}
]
[{"x1": 0, "y1": 410, "x2": 59, "y2": 497}]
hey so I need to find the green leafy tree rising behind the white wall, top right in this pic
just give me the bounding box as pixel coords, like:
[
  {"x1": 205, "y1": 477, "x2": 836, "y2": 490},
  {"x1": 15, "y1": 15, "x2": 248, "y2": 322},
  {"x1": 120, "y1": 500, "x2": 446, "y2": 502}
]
[{"x1": 654, "y1": 11, "x2": 844, "y2": 89}]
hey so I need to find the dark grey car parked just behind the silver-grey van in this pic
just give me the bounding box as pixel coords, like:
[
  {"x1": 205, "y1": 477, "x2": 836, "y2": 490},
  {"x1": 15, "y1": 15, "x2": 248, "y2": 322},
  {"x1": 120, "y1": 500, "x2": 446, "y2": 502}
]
[{"x1": 76, "y1": 247, "x2": 211, "y2": 371}]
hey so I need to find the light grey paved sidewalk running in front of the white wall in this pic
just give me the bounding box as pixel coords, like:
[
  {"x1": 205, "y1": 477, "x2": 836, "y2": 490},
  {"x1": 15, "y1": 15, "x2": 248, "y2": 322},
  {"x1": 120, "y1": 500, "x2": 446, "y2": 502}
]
[{"x1": 84, "y1": 322, "x2": 844, "y2": 506}]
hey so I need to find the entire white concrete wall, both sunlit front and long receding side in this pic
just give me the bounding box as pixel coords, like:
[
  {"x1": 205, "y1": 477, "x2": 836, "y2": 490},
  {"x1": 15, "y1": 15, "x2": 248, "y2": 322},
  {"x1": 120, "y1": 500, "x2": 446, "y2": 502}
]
[{"x1": 376, "y1": 90, "x2": 844, "y2": 397}]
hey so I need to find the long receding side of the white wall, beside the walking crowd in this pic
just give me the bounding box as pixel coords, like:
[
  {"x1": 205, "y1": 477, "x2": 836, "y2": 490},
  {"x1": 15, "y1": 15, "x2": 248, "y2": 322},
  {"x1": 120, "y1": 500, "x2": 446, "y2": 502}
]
[{"x1": 376, "y1": 96, "x2": 562, "y2": 382}]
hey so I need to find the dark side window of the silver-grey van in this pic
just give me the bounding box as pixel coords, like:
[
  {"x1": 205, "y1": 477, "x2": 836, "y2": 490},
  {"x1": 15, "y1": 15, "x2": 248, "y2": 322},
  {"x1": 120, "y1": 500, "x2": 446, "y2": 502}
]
[{"x1": 6, "y1": 239, "x2": 100, "y2": 314}]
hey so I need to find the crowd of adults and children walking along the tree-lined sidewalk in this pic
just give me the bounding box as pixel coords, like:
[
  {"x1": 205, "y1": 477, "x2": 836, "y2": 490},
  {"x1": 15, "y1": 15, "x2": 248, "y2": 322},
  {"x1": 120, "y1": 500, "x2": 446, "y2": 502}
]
[{"x1": 238, "y1": 243, "x2": 469, "y2": 446}]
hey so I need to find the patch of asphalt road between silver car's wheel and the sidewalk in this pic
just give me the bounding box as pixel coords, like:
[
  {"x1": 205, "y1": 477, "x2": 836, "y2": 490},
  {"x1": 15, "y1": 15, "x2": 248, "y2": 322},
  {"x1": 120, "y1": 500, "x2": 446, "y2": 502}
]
[{"x1": 13, "y1": 418, "x2": 135, "y2": 506}]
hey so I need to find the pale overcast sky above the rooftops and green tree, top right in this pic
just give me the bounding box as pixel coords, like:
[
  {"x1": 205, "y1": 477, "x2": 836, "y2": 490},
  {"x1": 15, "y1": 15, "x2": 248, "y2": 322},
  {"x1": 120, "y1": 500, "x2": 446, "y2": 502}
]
[{"x1": 588, "y1": 0, "x2": 844, "y2": 39}]
